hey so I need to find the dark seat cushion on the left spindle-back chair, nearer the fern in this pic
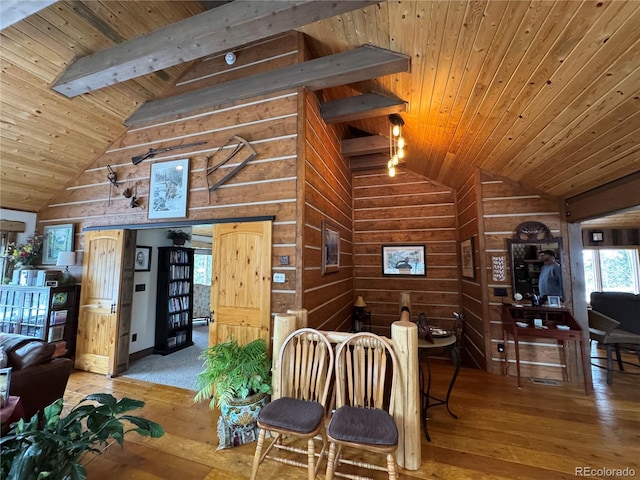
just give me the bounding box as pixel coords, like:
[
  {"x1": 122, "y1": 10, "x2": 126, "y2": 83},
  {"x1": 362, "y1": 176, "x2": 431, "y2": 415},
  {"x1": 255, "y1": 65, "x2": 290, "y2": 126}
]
[{"x1": 258, "y1": 397, "x2": 324, "y2": 433}]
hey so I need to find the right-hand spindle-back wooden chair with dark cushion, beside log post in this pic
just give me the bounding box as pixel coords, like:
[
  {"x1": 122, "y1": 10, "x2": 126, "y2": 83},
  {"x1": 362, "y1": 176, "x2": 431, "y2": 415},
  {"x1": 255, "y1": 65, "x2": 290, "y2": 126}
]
[{"x1": 326, "y1": 332, "x2": 398, "y2": 480}]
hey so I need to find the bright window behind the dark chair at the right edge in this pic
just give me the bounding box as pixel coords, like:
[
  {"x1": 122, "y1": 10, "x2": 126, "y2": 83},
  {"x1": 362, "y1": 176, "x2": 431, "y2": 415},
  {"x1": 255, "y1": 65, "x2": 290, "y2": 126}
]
[{"x1": 582, "y1": 247, "x2": 640, "y2": 303}]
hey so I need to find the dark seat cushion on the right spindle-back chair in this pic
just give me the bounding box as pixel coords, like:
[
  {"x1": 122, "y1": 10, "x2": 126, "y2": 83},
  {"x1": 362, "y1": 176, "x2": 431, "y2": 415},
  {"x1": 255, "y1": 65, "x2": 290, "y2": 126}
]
[{"x1": 328, "y1": 406, "x2": 398, "y2": 446}]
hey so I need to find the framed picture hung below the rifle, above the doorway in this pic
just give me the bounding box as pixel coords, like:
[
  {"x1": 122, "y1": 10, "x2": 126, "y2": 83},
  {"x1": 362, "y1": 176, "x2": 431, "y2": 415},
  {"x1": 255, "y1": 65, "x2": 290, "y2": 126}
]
[{"x1": 149, "y1": 158, "x2": 189, "y2": 219}]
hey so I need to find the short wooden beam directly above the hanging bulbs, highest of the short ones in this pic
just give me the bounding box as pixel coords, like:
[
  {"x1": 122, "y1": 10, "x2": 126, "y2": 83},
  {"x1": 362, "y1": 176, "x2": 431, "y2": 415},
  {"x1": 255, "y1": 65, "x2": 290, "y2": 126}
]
[{"x1": 320, "y1": 93, "x2": 407, "y2": 124}]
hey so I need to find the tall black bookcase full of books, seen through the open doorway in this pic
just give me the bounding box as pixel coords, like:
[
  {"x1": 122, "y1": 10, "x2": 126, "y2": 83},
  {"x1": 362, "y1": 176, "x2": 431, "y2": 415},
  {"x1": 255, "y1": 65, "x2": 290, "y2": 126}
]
[{"x1": 154, "y1": 247, "x2": 193, "y2": 355}]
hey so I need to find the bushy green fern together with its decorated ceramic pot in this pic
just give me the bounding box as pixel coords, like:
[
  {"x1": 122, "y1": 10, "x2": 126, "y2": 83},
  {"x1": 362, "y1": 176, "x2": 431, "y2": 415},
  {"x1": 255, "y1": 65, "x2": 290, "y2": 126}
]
[{"x1": 194, "y1": 338, "x2": 271, "y2": 448}]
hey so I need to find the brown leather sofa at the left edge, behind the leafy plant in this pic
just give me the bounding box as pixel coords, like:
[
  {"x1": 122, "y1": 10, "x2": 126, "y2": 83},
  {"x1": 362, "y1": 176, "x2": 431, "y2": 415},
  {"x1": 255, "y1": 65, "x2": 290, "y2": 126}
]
[{"x1": 0, "y1": 333, "x2": 73, "y2": 419}]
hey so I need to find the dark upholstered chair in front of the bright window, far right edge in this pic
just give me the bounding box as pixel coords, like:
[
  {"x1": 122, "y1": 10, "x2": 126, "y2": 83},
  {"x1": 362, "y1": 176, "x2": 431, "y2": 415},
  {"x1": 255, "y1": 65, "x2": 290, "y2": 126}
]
[{"x1": 589, "y1": 292, "x2": 640, "y2": 384}]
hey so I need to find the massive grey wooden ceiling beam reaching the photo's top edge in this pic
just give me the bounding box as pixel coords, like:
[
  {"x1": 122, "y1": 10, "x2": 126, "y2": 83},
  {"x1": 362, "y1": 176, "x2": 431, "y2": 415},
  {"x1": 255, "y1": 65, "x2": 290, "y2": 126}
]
[{"x1": 53, "y1": 0, "x2": 376, "y2": 97}]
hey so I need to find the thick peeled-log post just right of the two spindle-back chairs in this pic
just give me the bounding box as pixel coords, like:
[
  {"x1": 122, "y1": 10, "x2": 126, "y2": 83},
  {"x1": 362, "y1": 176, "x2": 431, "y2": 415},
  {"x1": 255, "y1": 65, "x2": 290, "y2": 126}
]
[{"x1": 391, "y1": 311, "x2": 422, "y2": 470}]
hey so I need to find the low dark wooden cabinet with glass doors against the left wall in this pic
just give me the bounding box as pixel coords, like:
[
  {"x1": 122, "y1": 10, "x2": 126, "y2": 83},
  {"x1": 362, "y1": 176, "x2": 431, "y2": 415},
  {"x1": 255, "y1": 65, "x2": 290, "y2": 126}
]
[{"x1": 0, "y1": 285, "x2": 80, "y2": 358}]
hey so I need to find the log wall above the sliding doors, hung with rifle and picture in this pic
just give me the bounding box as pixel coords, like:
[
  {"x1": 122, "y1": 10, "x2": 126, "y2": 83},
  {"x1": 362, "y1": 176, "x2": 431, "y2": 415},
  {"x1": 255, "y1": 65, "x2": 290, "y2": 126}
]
[{"x1": 38, "y1": 34, "x2": 304, "y2": 312}]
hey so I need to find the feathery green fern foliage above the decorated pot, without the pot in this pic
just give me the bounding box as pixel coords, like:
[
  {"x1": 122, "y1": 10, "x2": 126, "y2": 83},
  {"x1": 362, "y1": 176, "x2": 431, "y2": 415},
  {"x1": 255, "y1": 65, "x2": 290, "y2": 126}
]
[{"x1": 194, "y1": 338, "x2": 271, "y2": 413}]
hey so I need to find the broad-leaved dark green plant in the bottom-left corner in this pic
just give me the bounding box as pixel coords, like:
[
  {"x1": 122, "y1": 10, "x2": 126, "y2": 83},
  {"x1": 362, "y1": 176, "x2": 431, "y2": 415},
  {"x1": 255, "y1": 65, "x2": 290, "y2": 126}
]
[{"x1": 0, "y1": 393, "x2": 164, "y2": 480}]
